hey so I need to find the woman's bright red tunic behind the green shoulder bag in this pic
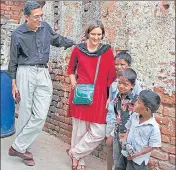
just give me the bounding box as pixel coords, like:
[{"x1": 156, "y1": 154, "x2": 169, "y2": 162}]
[{"x1": 67, "y1": 47, "x2": 116, "y2": 124}]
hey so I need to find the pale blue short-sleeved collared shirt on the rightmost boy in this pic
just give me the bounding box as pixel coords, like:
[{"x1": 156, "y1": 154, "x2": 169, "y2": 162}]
[{"x1": 122, "y1": 112, "x2": 161, "y2": 165}]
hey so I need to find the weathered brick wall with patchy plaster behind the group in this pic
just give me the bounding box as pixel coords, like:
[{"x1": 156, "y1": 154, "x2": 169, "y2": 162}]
[{"x1": 1, "y1": 1, "x2": 175, "y2": 170}]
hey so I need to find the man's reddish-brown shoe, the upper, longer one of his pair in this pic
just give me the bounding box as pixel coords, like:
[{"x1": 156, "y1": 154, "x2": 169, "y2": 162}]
[{"x1": 9, "y1": 147, "x2": 33, "y2": 160}]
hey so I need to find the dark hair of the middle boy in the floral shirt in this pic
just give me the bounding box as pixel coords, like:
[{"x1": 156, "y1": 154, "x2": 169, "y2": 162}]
[{"x1": 118, "y1": 68, "x2": 137, "y2": 84}]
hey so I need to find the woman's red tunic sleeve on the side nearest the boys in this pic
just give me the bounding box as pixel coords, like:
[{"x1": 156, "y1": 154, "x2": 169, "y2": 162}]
[{"x1": 108, "y1": 50, "x2": 117, "y2": 87}]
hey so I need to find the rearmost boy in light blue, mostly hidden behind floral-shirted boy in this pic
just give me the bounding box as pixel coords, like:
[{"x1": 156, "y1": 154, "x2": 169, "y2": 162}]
[{"x1": 106, "y1": 51, "x2": 142, "y2": 170}]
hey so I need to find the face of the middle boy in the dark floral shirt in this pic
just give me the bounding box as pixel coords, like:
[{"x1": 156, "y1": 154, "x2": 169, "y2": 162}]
[{"x1": 117, "y1": 76, "x2": 134, "y2": 94}]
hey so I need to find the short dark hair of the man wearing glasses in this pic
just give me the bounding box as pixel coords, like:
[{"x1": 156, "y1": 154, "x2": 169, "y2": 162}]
[{"x1": 24, "y1": 1, "x2": 41, "y2": 16}]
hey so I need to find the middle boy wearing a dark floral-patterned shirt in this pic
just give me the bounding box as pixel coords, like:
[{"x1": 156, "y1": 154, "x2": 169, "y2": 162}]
[{"x1": 110, "y1": 68, "x2": 137, "y2": 170}]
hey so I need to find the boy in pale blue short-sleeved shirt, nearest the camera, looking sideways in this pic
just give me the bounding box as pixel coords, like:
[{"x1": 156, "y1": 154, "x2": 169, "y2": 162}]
[{"x1": 119, "y1": 90, "x2": 161, "y2": 170}]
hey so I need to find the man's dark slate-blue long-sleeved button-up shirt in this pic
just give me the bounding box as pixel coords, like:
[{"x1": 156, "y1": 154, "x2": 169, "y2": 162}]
[{"x1": 8, "y1": 21, "x2": 75, "y2": 79}]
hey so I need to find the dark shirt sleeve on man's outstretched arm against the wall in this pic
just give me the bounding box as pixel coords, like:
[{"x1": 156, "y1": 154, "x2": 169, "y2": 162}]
[{"x1": 48, "y1": 25, "x2": 76, "y2": 49}]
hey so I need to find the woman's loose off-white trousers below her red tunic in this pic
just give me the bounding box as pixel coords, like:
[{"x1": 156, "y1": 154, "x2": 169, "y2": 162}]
[{"x1": 70, "y1": 118, "x2": 106, "y2": 165}]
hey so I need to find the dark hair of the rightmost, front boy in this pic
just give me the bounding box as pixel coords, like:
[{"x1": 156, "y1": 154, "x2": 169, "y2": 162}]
[{"x1": 139, "y1": 90, "x2": 161, "y2": 113}]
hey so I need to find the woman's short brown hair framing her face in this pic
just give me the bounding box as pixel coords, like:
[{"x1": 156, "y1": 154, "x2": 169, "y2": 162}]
[{"x1": 85, "y1": 20, "x2": 105, "y2": 39}]
